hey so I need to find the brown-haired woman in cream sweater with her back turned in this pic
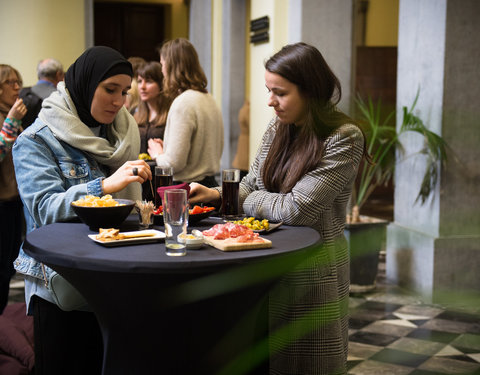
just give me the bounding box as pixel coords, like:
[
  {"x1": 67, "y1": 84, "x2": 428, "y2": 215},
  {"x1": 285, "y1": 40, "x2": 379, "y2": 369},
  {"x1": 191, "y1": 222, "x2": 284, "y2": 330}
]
[{"x1": 148, "y1": 38, "x2": 223, "y2": 186}]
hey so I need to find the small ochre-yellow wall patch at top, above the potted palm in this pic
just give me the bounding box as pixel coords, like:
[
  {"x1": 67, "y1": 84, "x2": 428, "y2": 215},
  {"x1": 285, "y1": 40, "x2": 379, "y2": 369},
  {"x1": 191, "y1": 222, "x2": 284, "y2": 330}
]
[{"x1": 365, "y1": 0, "x2": 399, "y2": 47}]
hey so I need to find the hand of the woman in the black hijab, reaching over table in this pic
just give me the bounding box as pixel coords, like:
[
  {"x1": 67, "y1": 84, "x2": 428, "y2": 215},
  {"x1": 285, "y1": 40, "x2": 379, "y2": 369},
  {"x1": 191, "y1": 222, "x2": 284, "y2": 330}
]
[{"x1": 102, "y1": 160, "x2": 152, "y2": 194}]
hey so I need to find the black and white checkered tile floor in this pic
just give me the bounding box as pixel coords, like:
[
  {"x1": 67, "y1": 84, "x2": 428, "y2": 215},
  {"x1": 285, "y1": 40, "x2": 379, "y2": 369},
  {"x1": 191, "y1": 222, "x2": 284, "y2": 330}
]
[{"x1": 10, "y1": 254, "x2": 480, "y2": 375}]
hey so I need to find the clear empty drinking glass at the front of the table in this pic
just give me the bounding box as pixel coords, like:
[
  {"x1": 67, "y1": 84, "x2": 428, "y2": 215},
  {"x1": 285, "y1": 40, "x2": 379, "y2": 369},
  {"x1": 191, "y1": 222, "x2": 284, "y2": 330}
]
[{"x1": 163, "y1": 189, "x2": 188, "y2": 256}]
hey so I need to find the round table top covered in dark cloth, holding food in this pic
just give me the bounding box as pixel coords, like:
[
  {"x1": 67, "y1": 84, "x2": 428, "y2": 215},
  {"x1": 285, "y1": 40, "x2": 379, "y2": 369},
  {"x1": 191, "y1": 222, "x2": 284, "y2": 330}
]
[{"x1": 23, "y1": 215, "x2": 320, "y2": 273}]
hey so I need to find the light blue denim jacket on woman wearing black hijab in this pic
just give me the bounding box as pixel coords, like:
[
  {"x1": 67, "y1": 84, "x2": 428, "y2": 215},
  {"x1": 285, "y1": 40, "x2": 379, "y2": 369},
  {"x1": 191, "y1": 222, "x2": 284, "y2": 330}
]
[{"x1": 12, "y1": 119, "x2": 106, "y2": 292}]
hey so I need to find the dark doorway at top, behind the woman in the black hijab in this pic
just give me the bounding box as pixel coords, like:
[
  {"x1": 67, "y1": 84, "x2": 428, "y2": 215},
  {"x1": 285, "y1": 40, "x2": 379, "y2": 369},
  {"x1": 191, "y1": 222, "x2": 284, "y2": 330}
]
[{"x1": 94, "y1": 2, "x2": 170, "y2": 61}]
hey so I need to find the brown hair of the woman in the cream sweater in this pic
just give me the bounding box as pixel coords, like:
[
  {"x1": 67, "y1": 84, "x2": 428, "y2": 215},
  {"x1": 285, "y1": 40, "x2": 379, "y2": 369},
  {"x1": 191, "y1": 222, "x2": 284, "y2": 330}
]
[{"x1": 159, "y1": 38, "x2": 208, "y2": 99}]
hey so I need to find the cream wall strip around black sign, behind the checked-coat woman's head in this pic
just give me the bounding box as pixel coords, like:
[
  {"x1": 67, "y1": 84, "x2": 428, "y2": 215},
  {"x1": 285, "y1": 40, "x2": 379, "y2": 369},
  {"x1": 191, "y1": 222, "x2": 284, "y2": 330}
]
[{"x1": 247, "y1": 0, "x2": 288, "y2": 162}]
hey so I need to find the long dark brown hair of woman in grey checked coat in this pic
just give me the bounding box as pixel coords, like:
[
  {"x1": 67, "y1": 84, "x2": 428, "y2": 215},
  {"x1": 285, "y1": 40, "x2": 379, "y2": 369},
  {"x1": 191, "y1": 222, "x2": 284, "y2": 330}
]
[{"x1": 263, "y1": 43, "x2": 360, "y2": 193}]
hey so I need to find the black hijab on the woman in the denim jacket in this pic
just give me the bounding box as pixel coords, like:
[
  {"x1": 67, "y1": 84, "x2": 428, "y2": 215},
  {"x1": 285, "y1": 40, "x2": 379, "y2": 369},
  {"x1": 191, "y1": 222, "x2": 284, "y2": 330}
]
[{"x1": 65, "y1": 46, "x2": 133, "y2": 128}]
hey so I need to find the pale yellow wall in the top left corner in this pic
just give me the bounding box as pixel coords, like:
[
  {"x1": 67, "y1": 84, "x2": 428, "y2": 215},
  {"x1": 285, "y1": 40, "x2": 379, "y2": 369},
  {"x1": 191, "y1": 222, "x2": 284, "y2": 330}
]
[{"x1": 0, "y1": 0, "x2": 85, "y2": 86}]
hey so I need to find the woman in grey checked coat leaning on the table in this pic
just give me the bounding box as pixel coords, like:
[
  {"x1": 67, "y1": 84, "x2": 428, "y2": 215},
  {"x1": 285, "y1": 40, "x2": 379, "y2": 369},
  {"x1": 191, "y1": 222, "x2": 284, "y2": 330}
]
[{"x1": 190, "y1": 43, "x2": 366, "y2": 375}]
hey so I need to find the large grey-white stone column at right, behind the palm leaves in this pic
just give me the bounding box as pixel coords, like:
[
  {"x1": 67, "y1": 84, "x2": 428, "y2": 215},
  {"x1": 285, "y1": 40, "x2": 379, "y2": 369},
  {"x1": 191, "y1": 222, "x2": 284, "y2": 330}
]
[{"x1": 387, "y1": 0, "x2": 480, "y2": 303}]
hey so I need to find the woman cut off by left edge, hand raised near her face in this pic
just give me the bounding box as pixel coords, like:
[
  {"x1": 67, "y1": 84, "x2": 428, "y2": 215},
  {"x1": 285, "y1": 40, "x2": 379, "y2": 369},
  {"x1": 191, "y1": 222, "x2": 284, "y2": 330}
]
[{"x1": 0, "y1": 64, "x2": 27, "y2": 314}]
